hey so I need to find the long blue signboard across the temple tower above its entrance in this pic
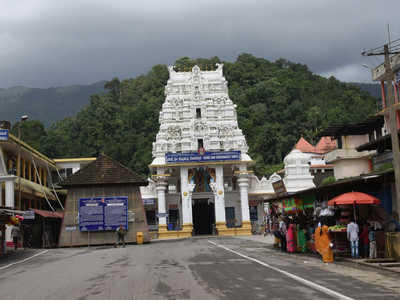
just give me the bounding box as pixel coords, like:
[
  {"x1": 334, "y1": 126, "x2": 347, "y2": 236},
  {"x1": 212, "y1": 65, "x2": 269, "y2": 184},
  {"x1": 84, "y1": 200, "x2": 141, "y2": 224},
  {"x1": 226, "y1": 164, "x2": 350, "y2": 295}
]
[{"x1": 165, "y1": 151, "x2": 240, "y2": 163}]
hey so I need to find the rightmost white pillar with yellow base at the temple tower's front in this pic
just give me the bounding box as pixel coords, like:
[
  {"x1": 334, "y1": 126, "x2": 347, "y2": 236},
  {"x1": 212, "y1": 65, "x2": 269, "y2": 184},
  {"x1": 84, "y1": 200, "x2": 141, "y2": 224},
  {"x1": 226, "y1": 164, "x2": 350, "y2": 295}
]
[{"x1": 238, "y1": 166, "x2": 251, "y2": 235}]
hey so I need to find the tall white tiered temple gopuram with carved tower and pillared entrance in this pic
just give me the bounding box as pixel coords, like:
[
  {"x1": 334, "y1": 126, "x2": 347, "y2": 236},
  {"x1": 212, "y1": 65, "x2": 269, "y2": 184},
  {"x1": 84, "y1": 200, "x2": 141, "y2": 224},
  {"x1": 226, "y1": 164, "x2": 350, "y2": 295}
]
[{"x1": 141, "y1": 64, "x2": 313, "y2": 239}]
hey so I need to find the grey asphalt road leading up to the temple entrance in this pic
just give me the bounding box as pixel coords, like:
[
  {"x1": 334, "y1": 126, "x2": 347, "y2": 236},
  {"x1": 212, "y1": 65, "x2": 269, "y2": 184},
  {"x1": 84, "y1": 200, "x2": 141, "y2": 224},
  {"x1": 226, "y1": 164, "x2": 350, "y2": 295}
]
[{"x1": 0, "y1": 238, "x2": 400, "y2": 300}]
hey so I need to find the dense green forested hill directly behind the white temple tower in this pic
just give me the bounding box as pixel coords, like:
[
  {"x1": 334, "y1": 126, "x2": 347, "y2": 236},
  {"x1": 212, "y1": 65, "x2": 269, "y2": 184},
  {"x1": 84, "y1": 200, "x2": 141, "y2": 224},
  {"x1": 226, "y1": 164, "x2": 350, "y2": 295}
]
[{"x1": 15, "y1": 54, "x2": 376, "y2": 174}]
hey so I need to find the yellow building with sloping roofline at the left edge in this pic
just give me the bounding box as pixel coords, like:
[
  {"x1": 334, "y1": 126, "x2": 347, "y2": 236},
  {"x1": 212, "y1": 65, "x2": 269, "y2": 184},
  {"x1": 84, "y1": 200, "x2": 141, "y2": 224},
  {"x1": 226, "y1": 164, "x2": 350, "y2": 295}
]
[{"x1": 0, "y1": 129, "x2": 63, "y2": 250}]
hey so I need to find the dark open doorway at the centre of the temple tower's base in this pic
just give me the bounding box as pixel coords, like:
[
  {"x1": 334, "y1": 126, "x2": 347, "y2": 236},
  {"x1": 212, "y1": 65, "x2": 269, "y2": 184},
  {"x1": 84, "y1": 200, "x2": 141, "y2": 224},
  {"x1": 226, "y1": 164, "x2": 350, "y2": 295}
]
[{"x1": 193, "y1": 199, "x2": 215, "y2": 235}]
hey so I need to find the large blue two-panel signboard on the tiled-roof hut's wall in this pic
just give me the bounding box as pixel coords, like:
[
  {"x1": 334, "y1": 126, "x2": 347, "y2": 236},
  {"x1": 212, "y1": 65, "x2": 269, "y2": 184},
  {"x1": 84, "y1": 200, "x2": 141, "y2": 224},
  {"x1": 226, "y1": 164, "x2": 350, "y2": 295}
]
[{"x1": 79, "y1": 197, "x2": 128, "y2": 231}]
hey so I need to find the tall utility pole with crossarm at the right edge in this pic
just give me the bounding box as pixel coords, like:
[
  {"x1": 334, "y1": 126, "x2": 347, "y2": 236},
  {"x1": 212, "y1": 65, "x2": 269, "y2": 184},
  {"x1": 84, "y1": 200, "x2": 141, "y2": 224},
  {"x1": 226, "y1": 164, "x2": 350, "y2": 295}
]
[{"x1": 362, "y1": 44, "x2": 400, "y2": 216}]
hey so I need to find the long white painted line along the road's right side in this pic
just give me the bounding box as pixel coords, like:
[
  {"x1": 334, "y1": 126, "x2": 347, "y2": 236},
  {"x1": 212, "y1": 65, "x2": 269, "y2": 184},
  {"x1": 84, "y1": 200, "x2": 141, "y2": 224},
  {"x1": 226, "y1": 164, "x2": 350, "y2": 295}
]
[{"x1": 208, "y1": 241, "x2": 354, "y2": 300}]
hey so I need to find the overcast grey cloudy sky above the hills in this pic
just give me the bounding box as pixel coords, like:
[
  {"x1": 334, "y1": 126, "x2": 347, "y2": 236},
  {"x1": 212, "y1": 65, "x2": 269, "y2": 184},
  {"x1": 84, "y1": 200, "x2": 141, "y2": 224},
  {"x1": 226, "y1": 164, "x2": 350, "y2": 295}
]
[{"x1": 0, "y1": 0, "x2": 400, "y2": 87}]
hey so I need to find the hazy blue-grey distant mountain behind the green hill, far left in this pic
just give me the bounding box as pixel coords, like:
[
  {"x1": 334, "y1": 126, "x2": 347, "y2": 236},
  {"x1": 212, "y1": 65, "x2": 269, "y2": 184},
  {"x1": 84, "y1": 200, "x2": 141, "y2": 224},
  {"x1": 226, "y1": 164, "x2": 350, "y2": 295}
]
[{"x1": 0, "y1": 81, "x2": 104, "y2": 127}]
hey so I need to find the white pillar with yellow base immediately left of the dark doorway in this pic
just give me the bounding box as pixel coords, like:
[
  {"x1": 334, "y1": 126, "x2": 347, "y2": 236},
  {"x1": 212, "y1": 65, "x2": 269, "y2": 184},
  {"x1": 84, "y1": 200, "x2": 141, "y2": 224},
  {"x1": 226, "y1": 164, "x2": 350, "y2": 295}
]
[{"x1": 180, "y1": 167, "x2": 195, "y2": 237}]
